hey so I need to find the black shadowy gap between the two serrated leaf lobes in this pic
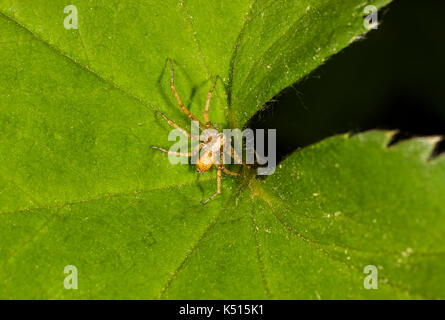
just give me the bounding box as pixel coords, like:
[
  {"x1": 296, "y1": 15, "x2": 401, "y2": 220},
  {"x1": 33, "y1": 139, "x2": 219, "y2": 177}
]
[{"x1": 248, "y1": 0, "x2": 445, "y2": 160}]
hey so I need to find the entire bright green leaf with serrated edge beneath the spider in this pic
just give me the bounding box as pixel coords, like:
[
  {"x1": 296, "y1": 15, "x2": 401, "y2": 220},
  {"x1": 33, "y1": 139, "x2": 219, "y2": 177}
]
[{"x1": 4, "y1": 0, "x2": 445, "y2": 299}]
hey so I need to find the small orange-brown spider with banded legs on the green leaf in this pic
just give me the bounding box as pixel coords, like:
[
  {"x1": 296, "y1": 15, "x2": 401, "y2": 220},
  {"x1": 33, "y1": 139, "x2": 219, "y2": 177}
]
[{"x1": 152, "y1": 59, "x2": 250, "y2": 204}]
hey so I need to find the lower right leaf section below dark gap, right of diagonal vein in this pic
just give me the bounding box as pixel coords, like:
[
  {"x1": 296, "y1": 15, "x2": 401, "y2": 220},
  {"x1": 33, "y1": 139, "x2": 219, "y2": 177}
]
[{"x1": 153, "y1": 131, "x2": 445, "y2": 299}]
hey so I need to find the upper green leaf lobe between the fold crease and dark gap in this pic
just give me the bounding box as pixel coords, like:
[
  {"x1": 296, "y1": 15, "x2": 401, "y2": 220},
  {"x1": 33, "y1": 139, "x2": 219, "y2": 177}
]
[{"x1": 229, "y1": 0, "x2": 390, "y2": 126}]
